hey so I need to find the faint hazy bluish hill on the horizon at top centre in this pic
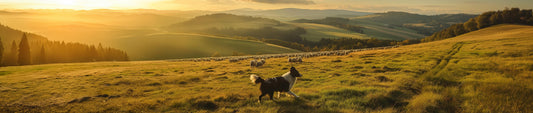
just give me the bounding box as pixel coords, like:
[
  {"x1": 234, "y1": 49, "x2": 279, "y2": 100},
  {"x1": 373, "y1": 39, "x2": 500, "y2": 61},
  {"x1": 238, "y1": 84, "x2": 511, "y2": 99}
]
[{"x1": 222, "y1": 8, "x2": 372, "y2": 21}]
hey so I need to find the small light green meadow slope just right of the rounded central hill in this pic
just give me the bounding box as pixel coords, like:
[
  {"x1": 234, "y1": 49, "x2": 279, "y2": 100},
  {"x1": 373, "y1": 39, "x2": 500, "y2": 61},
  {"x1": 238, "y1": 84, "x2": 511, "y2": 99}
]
[{"x1": 291, "y1": 23, "x2": 370, "y2": 41}]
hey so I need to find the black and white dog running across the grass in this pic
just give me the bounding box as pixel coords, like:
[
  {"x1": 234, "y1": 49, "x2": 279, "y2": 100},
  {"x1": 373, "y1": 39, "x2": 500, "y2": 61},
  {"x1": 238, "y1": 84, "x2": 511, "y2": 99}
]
[{"x1": 250, "y1": 67, "x2": 302, "y2": 102}]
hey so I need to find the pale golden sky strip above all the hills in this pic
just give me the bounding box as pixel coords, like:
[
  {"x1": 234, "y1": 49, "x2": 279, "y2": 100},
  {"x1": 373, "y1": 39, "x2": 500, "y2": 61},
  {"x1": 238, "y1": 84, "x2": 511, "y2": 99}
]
[{"x1": 0, "y1": 0, "x2": 533, "y2": 15}]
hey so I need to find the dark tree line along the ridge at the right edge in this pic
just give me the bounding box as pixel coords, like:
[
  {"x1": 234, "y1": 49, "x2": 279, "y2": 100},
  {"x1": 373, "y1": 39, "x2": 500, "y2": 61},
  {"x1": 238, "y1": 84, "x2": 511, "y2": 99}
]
[{"x1": 421, "y1": 8, "x2": 533, "y2": 42}]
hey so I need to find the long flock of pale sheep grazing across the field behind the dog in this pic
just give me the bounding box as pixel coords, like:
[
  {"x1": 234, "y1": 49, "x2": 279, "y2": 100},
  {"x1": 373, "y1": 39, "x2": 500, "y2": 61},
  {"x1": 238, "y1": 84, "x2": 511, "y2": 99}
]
[{"x1": 170, "y1": 46, "x2": 399, "y2": 63}]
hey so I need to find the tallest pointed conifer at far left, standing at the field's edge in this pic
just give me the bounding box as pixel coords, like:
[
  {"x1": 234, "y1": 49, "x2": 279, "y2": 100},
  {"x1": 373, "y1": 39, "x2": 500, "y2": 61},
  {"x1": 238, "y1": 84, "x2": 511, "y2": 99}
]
[{"x1": 18, "y1": 33, "x2": 31, "y2": 65}]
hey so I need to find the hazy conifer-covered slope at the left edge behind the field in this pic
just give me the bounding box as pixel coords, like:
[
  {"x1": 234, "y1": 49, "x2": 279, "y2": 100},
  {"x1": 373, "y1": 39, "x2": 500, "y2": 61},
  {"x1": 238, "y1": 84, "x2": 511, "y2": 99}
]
[{"x1": 0, "y1": 33, "x2": 129, "y2": 66}]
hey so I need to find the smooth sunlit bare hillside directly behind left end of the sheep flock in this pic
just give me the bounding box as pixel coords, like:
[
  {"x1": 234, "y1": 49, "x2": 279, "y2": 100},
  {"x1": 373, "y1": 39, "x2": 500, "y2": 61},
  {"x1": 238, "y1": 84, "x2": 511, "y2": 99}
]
[{"x1": 113, "y1": 33, "x2": 299, "y2": 60}]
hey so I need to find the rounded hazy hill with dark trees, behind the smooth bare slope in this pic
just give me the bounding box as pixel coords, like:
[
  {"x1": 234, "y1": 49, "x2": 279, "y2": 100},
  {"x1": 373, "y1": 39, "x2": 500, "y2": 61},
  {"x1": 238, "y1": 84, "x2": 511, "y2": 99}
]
[{"x1": 164, "y1": 13, "x2": 306, "y2": 42}]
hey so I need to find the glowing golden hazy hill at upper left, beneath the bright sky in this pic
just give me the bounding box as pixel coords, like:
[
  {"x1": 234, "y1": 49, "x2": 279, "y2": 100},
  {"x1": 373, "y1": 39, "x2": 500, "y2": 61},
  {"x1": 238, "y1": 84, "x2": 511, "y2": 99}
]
[{"x1": 0, "y1": 9, "x2": 211, "y2": 44}]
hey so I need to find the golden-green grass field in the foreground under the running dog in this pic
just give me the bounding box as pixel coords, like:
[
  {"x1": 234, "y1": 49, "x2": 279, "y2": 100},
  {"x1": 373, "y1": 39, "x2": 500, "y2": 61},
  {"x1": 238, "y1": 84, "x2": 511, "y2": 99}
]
[{"x1": 0, "y1": 25, "x2": 533, "y2": 113}]
